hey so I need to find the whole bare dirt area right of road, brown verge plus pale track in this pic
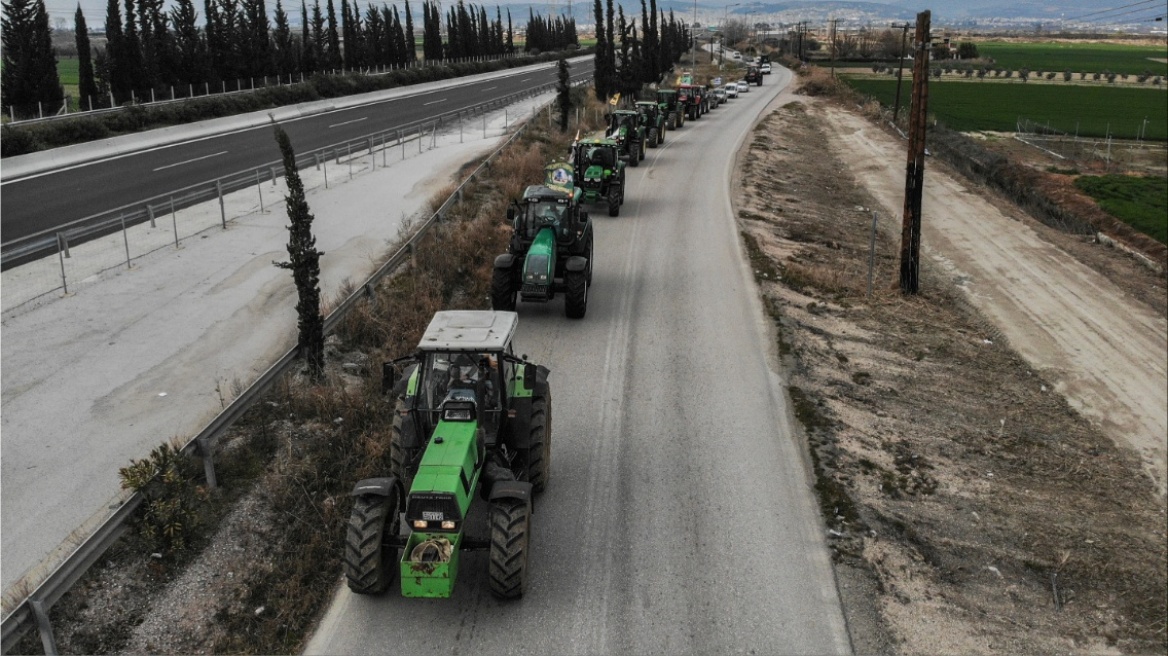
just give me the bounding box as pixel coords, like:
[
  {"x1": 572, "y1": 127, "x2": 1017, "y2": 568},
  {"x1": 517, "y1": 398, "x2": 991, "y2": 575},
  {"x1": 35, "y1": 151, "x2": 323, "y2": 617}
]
[{"x1": 736, "y1": 74, "x2": 1168, "y2": 656}]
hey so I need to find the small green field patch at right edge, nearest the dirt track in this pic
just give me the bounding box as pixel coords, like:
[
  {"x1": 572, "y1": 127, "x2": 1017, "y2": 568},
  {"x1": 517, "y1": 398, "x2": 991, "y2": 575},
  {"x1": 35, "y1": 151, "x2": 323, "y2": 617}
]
[{"x1": 1075, "y1": 175, "x2": 1168, "y2": 244}]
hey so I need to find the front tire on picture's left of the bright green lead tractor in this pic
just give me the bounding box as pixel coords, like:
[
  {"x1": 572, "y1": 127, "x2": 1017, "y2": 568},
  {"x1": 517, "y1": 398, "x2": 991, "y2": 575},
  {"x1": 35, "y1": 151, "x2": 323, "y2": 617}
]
[{"x1": 345, "y1": 491, "x2": 399, "y2": 594}]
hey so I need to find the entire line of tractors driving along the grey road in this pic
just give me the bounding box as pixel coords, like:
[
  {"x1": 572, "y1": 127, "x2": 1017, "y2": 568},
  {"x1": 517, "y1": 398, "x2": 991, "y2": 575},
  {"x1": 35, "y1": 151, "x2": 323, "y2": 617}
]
[{"x1": 343, "y1": 61, "x2": 757, "y2": 599}]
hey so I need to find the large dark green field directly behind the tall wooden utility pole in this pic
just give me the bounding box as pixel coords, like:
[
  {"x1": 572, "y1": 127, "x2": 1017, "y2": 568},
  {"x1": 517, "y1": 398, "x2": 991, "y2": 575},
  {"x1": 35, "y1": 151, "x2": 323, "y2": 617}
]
[{"x1": 843, "y1": 77, "x2": 1168, "y2": 141}]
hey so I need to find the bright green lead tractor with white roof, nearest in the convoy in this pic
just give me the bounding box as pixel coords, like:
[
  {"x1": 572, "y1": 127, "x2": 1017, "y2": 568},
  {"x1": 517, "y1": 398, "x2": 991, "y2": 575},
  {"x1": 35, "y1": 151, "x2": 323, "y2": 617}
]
[{"x1": 343, "y1": 312, "x2": 551, "y2": 599}]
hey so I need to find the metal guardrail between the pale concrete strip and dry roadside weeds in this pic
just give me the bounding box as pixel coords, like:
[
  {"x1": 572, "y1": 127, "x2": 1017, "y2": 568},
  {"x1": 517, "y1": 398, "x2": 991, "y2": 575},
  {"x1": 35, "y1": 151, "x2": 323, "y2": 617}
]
[{"x1": 0, "y1": 81, "x2": 586, "y2": 655}]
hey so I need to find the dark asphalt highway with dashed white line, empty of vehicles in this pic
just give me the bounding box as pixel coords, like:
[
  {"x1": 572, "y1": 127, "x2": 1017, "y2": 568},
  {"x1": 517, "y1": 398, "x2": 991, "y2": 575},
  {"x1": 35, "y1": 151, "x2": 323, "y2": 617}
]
[{"x1": 0, "y1": 60, "x2": 592, "y2": 243}]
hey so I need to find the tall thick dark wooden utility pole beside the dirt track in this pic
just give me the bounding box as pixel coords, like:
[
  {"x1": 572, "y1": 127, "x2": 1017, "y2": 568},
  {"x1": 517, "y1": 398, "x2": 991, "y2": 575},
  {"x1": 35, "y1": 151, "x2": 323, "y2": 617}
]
[{"x1": 901, "y1": 9, "x2": 931, "y2": 294}]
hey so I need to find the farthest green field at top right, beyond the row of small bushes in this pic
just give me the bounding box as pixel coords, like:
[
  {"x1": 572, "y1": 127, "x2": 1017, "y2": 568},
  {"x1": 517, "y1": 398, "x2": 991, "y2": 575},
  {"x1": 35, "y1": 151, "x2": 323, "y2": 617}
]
[{"x1": 978, "y1": 42, "x2": 1168, "y2": 76}]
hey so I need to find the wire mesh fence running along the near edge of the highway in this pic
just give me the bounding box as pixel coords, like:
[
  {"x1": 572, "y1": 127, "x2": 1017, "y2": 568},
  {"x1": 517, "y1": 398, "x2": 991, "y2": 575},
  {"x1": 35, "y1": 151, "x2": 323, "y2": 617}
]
[{"x1": 0, "y1": 84, "x2": 574, "y2": 315}]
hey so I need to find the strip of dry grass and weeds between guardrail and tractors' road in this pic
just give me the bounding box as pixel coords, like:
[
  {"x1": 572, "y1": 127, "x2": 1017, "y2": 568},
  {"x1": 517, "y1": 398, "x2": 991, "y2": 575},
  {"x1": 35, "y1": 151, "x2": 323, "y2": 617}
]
[{"x1": 19, "y1": 88, "x2": 603, "y2": 654}]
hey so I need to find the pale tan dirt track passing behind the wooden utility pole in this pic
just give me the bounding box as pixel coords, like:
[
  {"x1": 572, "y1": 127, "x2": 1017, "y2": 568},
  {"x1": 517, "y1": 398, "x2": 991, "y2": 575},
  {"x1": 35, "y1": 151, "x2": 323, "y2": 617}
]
[{"x1": 822, "y1": 107, "x2": 1168, "y2": 495}]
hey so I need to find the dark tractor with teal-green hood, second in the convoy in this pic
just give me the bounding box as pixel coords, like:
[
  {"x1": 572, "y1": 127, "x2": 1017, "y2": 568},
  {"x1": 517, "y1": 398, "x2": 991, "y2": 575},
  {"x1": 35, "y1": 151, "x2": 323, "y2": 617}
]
[{"x1": 491, "y1": 162, "x2": 592, "y2": 319}]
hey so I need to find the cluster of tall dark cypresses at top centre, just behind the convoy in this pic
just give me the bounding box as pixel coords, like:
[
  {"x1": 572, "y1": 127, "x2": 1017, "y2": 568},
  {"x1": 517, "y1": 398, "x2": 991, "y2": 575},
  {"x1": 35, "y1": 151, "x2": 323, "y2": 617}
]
[{"x1": 592, "y1": 0, "x2": 690, "y2": 100}]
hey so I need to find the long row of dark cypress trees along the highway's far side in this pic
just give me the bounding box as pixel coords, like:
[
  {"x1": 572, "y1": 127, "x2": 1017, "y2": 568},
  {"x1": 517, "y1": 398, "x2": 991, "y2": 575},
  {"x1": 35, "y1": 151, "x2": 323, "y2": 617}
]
[{"x1": 2, "y1": 0, "x2": 578, "y2": 116}]
